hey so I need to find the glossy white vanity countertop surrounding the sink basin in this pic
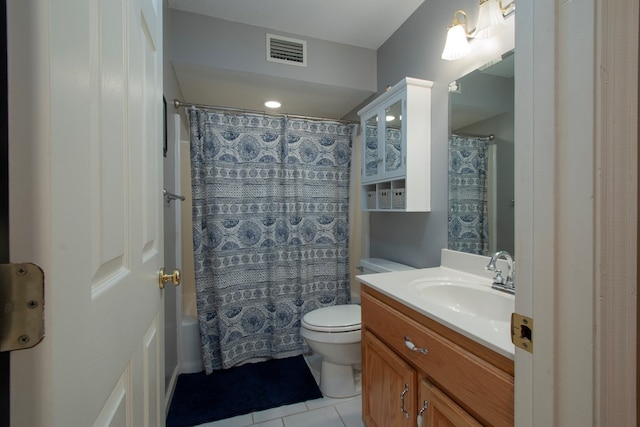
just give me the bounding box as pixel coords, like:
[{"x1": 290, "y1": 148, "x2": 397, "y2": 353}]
[{"x1": 356, "y1": 266, "x2": 515, "y2": 360}]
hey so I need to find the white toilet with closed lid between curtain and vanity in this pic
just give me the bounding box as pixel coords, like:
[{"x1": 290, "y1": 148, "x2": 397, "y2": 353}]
[{"x1": 300, "y1": 258, "x2": 413, "y2": 398}]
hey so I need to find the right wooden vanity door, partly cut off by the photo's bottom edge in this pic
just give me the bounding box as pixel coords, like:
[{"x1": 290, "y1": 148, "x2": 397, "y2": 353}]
[{"x1": 418, "y1": 380, "x2": 482, "y2": 427}]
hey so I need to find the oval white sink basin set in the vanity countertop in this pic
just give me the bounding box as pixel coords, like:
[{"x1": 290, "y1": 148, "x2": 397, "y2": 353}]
[{"x1": 410, "y1": 278, "x2": 515, "y2": 322}]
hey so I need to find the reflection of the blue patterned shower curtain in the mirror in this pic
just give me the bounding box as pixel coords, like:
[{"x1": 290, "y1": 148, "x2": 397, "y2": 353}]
[{"x1": 448, "y1": 135, "x2": 489, "y2": 255}]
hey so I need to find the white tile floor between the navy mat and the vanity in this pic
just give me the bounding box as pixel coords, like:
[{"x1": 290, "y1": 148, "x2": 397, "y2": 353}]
[{"x1": 190, "y1": 355, "x2": 364, "y2": 427}]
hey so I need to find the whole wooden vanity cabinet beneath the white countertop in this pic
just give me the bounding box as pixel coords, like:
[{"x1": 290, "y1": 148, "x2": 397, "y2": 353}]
[{"x1": 362, "y1": 285, "x2": 514, "y2": 427}]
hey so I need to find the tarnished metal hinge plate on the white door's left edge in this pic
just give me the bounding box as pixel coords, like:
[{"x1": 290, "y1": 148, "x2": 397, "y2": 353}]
[{"x1": 0, "y1": 263, "x2": 44, "y2": 351}]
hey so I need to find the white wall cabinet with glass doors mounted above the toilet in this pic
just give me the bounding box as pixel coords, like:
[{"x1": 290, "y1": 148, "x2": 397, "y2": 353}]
[{"x1": 358, "y1": 77, "x2": 433, "y2": 212}]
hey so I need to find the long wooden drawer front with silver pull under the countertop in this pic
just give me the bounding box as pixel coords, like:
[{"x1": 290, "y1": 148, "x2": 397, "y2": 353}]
[{"x1": 362, "y1": 293, "x2": 513, "y2": 426}]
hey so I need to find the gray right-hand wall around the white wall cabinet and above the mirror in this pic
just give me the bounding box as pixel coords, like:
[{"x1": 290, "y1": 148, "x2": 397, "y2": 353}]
[{"x1": 370, "y1": 0, "x2": 514, "y2": 267}]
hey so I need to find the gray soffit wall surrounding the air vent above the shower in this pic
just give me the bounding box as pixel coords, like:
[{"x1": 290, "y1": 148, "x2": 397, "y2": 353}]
[{"x1": 169, "y1": 10, "x2": 376, "y2": 92}]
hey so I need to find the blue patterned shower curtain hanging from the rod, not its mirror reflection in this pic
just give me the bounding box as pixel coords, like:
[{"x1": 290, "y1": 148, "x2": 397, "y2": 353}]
[{"x1": 190, "y1": 109, "x2": 353, "y2": 373}]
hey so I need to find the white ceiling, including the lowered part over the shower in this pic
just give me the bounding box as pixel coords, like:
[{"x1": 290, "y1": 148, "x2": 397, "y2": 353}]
[{"x1": 168, "y1": 0, "x2": 424, "y2": 119}]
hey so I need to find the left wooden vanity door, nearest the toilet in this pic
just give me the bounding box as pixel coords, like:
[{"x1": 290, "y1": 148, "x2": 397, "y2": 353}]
[{"x1": 362, "y1": 330, "x2": 417, "y2": 427}]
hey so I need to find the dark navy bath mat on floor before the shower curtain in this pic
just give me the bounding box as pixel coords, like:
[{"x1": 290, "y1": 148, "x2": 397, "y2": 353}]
[{"x1": 167, "y1": 355, "x2": 322, "y2": 427}]
